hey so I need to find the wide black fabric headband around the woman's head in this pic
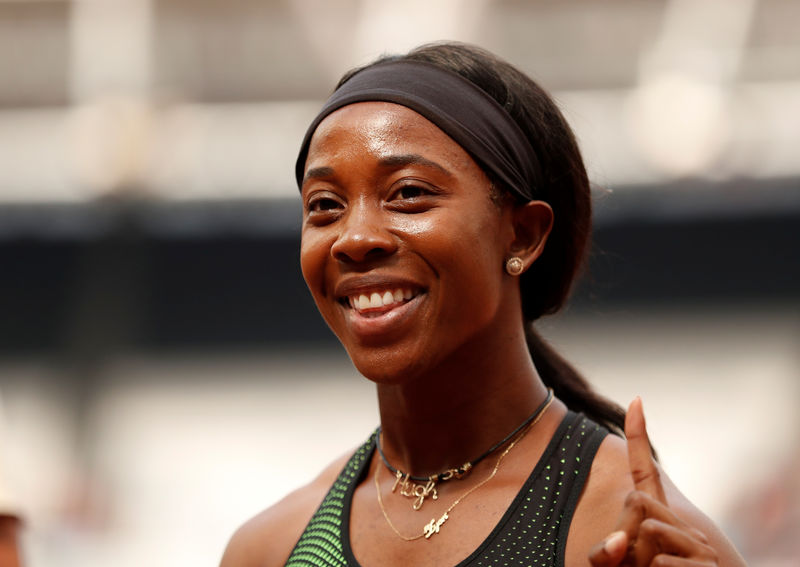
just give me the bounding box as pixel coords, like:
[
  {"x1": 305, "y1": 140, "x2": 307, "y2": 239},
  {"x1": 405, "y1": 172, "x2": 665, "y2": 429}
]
[{"x1": 295, "y1": 61, "x2": 539, "y2": 200}]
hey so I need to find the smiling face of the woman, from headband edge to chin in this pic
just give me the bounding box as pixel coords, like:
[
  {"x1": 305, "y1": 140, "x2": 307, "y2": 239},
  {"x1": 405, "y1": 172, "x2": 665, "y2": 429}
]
[{"x1": 300, "y1": 102, "x2": 518, "y2": 383}]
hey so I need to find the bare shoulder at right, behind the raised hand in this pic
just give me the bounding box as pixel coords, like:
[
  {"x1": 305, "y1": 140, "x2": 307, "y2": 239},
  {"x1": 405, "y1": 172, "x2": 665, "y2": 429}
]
[{"x1": 565, "y1": 434, "x2": 738, "y2": 565}]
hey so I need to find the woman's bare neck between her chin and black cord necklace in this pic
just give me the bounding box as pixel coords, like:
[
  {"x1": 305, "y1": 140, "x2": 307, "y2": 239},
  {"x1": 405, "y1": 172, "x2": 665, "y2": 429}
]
[{"x1": 378, "y1": 324, "x2": 547, "y2": 476}]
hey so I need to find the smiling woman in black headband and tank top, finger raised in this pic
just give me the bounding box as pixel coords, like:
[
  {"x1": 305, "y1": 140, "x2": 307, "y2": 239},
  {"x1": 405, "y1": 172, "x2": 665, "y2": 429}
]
[{"x1": 222, "y1": 44, "x2": 744, "y2": 567}]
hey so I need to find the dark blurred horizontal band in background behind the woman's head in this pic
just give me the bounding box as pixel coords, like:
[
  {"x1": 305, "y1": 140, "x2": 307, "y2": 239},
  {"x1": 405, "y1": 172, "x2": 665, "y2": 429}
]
[{"x1": 0, "y1": 180, "x2": 800, "y2": 359}]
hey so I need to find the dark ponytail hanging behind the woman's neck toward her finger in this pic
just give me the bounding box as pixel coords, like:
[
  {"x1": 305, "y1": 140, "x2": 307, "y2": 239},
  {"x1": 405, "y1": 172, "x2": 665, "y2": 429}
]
[{"x1": 525, "y1": 323, "x2": 625, "y2": 435}]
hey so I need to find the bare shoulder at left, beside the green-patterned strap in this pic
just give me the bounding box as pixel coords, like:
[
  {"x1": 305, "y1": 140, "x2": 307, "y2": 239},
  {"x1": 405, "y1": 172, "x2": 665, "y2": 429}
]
[{"x1": 220, "y1": 451, "x2": 352, "y2": 567}]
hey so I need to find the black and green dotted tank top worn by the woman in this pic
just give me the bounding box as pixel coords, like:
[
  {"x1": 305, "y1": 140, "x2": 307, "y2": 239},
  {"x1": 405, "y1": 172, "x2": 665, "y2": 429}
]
[{"x1": 286, "y1": 412, "x2": 608, "y2": 567}]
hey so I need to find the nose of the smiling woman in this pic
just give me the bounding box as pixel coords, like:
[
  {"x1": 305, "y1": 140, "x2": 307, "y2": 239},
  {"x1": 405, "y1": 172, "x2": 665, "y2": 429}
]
[{"x1": 331, "y1": 204, "x2": 397, "y2": 263}]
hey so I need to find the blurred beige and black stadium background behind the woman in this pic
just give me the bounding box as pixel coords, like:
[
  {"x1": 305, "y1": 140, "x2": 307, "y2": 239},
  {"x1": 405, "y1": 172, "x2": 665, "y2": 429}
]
[{"x1": 0, "y1": 0, "x2": 800, "y2": 567}]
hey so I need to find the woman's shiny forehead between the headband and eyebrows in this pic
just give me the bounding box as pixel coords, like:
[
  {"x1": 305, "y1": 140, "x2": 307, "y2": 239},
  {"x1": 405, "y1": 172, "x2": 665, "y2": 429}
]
[{"x1": 306, "y1": 102, "x2": 476, "y2": 167}]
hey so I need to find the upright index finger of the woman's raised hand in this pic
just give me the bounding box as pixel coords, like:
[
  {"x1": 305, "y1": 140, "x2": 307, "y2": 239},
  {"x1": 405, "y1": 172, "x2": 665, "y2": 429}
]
[{"x1": 625, "y1": 396, "x2": 667, "y2": 505}]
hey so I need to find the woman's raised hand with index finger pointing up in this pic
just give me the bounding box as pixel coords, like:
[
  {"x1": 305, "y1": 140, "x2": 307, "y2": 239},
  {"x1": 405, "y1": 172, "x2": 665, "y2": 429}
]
[{"x1": 589, "y1": 397, "x2": 719, "y2": 567}]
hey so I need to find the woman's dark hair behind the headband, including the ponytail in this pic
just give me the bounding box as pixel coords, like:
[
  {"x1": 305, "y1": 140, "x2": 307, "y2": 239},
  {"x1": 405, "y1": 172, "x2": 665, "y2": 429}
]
[{"x1": 337, "y1": 42, "x2": 625, "y2": 438}]
